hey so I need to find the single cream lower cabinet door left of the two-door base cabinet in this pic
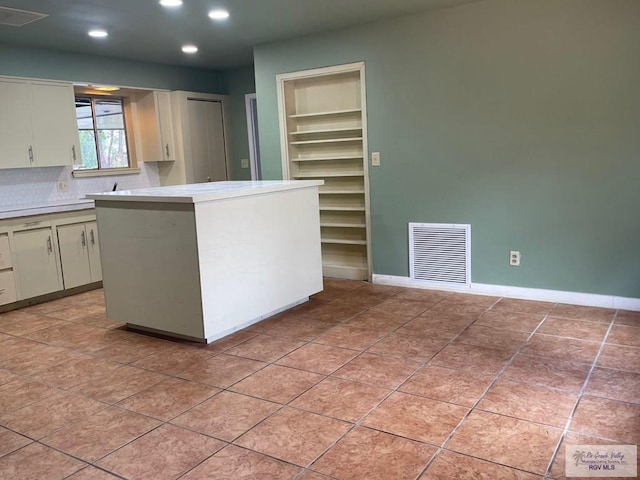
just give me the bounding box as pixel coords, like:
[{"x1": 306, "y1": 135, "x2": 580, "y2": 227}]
[{"x1": 13, "y1": 227, "x2": 62, "y2": 300}]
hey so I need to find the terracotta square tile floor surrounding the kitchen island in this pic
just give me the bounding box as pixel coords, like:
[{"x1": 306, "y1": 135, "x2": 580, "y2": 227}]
[{"x1": 0, "y1": 279, "x2": 640, "y2": 480}]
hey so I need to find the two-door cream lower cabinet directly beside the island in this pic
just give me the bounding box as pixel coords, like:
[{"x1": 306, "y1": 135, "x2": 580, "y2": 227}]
[{"x1": 57, "y1": 222, "x2": 102, "y2": 289}]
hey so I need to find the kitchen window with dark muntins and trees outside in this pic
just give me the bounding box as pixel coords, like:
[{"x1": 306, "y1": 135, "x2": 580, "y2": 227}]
[{"x1": 74, "y1": 96, "x2": 130, "y2": 170}]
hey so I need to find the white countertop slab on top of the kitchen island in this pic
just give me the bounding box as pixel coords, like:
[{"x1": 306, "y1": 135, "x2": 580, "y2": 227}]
[{"x1": 87, "y1": 180, "x2": 324, "y2": 203}]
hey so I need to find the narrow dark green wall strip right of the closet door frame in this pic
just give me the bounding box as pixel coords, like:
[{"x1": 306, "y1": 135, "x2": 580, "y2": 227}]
[{"x1": 223, "y1": 67, "x2": 256, "y2": 180}]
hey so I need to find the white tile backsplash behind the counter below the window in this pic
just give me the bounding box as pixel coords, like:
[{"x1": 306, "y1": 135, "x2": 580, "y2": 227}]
[{"x1": 0, "y1": 163, "x2": 160, "y2": 207}]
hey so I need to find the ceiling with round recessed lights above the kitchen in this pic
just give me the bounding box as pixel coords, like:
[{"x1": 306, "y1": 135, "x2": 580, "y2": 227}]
[{"x1": 0, "y1": 0, "x2": 478, "y2": 69}]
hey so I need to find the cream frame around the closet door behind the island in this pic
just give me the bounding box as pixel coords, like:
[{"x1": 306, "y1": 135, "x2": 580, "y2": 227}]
[{"x1": 164, "y1": 90, "x2": 233, "y2": 185}]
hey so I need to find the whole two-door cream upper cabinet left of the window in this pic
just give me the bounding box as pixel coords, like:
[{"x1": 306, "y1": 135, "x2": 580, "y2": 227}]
[{"x1": 0, "y1": 78, "x2": 80, "y2": 168}]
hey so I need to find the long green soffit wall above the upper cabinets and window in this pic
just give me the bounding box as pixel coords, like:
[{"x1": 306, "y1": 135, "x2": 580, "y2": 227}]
[{"x1": 0, "y1": 45, "x2": 225, "y2": 93}]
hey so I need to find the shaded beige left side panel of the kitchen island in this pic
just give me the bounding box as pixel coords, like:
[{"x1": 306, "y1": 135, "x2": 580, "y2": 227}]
[{"x1": 96, "y1": 200, "x2": 205, "y2": 340}]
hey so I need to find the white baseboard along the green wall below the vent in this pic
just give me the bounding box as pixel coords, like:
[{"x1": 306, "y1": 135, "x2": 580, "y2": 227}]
[{"x1": 372, "y1": 274, "x2": 640, "y2": 311}]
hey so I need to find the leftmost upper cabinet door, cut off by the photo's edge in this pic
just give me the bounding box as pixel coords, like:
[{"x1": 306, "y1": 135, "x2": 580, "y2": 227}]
[{"x1": 0, "y1": 80, "x2": 32, "y2": 168}]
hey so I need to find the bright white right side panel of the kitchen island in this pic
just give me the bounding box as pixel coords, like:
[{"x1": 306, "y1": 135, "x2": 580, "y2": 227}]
[{"x1": 196, "y1": 186, "x2": 322, "y2": 340}]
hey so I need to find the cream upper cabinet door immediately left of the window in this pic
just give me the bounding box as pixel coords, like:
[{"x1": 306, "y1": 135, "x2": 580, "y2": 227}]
[{"x1": 31, "y1": 83, "x2": 80, "y2": 167}]
